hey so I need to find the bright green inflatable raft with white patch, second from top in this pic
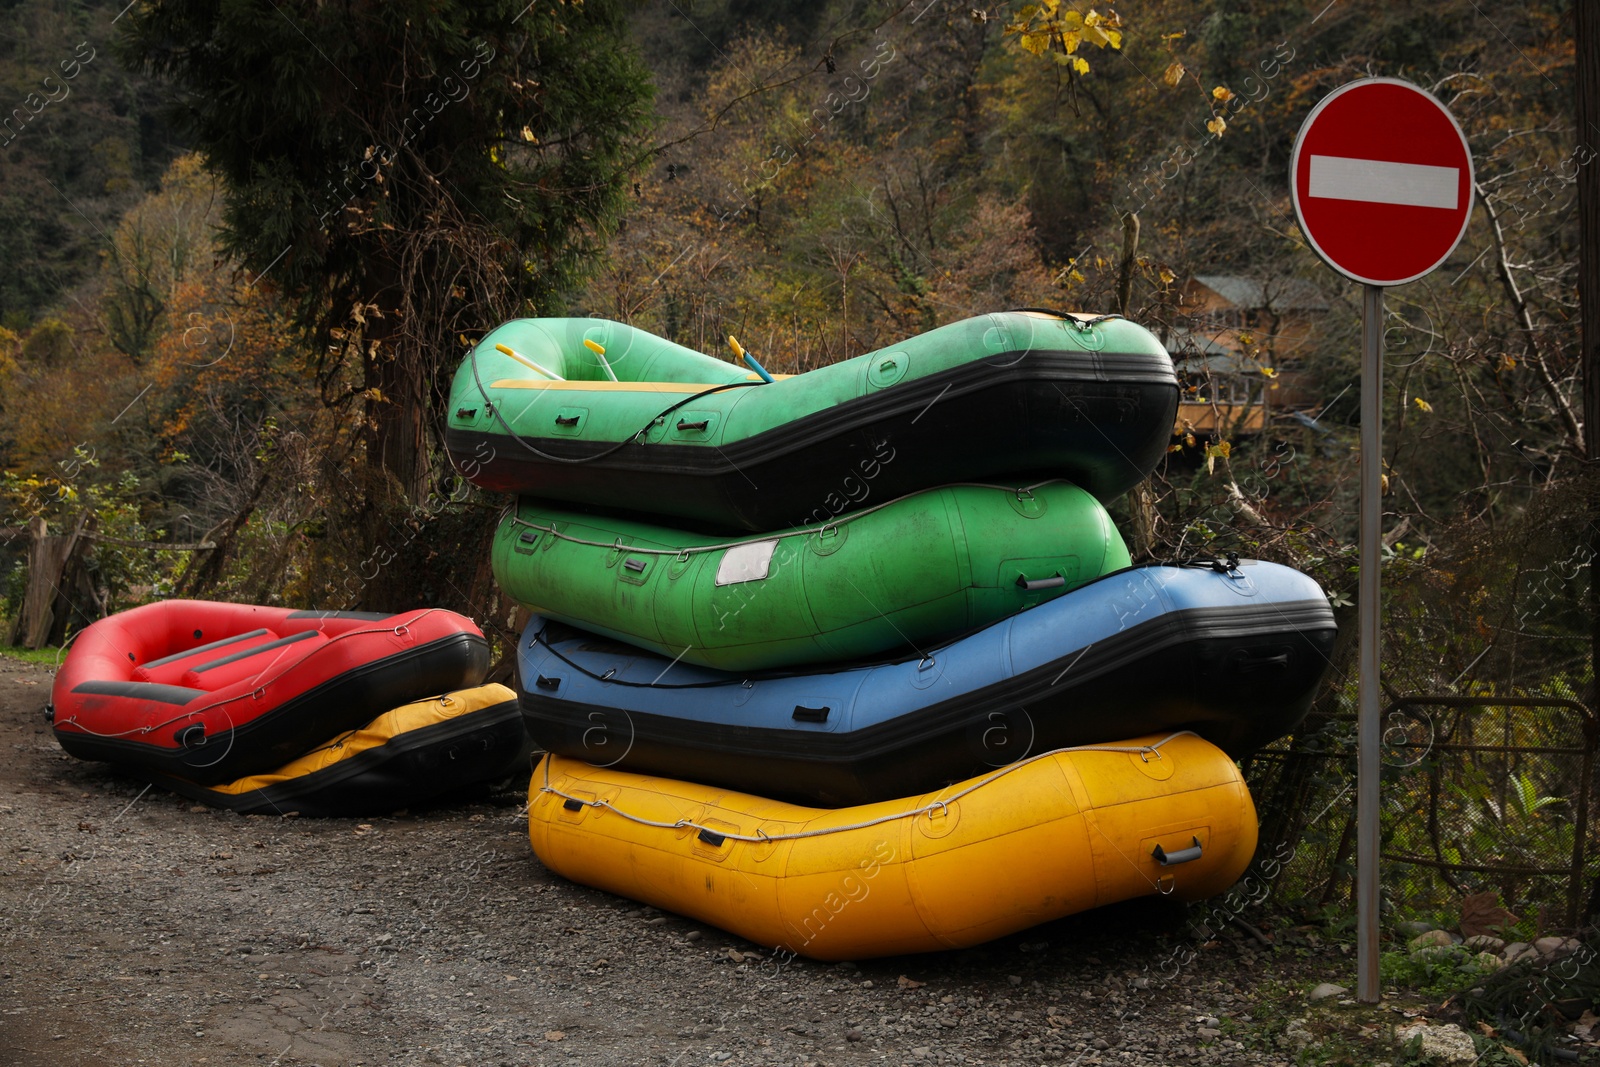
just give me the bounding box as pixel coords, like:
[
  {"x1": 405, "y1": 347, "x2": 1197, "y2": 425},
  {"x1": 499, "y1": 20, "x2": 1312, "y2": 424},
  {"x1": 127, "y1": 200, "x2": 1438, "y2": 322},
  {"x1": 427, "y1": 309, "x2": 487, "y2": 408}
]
[{"x1": 493, "y1": 482, "x2": 1130, "y2": 670}]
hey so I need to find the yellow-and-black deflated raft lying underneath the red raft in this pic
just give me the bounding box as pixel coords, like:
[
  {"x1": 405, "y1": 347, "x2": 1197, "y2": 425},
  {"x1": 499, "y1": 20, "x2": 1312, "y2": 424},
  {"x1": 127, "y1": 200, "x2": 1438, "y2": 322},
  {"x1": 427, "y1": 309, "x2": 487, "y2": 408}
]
[{"x1": 147, "y1": 683, "x2": 528, "y2": 816}]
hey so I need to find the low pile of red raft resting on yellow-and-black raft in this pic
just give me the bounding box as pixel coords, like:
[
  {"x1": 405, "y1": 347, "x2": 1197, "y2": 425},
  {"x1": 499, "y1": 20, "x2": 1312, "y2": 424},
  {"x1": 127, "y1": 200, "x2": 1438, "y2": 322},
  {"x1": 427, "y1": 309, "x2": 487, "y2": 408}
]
[{"x1": 48, "y1": 600, "x2": 526, "y2": 816}]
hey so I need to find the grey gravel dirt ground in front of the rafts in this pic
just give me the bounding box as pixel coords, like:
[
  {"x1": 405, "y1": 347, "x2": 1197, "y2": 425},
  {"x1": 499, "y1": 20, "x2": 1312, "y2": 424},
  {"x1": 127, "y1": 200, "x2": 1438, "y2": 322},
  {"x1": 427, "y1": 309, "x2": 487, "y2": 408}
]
[{"x1": 0, "y1": 657, "x2": 1378, "y2": 1067}]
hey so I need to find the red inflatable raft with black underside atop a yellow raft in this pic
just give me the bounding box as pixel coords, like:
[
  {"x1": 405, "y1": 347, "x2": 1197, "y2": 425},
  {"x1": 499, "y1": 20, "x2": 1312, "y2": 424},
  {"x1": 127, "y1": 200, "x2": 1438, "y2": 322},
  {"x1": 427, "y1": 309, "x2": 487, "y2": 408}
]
[{"x1": 50, "y1": 600, "x2": 490, "y2": 785}]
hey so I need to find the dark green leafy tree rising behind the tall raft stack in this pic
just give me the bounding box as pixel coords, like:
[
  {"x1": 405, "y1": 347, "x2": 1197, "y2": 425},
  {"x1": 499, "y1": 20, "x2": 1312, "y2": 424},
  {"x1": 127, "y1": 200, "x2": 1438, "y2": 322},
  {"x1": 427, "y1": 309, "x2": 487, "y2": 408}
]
[{"x1": 118, "y1": 0, "x2": 650, "y2": 499}]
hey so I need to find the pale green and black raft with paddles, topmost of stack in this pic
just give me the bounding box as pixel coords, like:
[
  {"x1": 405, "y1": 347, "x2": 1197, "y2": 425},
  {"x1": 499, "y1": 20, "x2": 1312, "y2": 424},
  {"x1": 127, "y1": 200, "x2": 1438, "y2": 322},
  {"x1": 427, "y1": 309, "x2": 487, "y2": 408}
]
[{"x1": 445, "y1": 310, "x2": 1178, "y2": 531}]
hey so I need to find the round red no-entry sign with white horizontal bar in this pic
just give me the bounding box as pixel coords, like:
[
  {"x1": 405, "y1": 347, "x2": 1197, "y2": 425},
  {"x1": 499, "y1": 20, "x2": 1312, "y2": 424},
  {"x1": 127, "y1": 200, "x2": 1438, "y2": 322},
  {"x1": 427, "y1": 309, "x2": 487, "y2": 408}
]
[{"x1": 1290, "y1": 78, "x2": 1472, "y2": 285}]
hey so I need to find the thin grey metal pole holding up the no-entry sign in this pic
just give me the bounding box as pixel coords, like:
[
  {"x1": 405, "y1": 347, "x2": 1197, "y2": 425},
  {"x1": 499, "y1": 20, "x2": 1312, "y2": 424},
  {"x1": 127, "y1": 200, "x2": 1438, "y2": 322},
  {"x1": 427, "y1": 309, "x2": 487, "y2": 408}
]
[{"x1": 1355, "y1": 285, "x2": 1384, "y2": 1005}]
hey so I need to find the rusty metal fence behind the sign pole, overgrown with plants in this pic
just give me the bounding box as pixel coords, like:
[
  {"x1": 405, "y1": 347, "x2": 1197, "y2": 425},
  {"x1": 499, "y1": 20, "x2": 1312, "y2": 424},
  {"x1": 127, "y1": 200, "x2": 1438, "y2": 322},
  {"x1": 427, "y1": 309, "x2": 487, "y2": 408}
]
[{"x1": 1245, "y1": 696, "x2": 1600, "y2": 937}]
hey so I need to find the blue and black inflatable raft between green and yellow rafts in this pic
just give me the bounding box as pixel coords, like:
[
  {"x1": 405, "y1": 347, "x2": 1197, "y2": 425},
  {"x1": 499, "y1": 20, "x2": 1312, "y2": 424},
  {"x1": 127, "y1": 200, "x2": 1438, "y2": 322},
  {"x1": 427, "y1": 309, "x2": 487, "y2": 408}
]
[{"x1": 518, "y1": 558, "x2": 1334, "y2": 806}]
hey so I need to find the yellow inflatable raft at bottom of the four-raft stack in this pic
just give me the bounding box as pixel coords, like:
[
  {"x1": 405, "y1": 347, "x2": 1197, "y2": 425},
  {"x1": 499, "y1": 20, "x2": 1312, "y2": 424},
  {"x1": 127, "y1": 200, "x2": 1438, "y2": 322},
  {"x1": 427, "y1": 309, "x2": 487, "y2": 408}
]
[{"x1": 528, "y1": 733, "x2": 1256, "y2": 960}]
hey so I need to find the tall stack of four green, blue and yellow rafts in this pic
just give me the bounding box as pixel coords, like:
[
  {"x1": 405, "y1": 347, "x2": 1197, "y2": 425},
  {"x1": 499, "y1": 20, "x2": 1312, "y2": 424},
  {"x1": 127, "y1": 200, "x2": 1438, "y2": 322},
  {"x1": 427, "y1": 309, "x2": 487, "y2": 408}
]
[{"x1": 446, "y1": 310, "x2": 1334, "y2": 958}]
